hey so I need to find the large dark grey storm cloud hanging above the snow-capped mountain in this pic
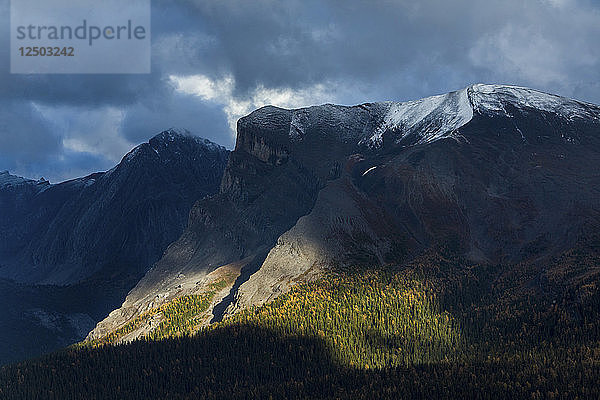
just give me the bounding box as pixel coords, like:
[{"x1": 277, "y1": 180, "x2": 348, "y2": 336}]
[{"x1": 178, "y1": 0, "x2": 600, "y2": 101}]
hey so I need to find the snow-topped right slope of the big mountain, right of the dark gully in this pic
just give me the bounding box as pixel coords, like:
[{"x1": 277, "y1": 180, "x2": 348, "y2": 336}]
[{"x1": 233, "y1": 85, "x2": 600, "y2": 309}]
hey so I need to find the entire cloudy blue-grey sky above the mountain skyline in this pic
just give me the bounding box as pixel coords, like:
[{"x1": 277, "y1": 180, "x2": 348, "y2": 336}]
[{"x1": 0, "y1": 0, "x2": 600, "y2": 182}]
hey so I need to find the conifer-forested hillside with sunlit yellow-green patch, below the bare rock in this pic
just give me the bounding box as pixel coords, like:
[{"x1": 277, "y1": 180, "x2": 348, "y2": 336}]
[{"x1": 0, "y1": 240, "x2": 600, "y2": 399}]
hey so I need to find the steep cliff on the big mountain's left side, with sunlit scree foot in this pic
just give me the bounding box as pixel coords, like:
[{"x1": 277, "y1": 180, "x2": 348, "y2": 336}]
[{"x1": 90, "y1": 106, "x2": 366, "y2": 337}]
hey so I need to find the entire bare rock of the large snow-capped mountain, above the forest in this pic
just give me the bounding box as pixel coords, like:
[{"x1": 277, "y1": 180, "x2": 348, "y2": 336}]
[{"x1": 89, "y1": 85, "x2": 600, "y2": 338}]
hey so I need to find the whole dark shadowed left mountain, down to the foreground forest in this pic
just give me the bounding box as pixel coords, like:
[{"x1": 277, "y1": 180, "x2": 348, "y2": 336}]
[{"x1": 0, "y1": 130, "x2": 229, "y2": 362}]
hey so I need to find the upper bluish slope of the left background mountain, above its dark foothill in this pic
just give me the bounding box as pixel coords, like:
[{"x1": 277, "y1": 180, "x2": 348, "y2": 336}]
[{"x1": 0, "y1": 131, "x2": 227, "y2": 285}]
